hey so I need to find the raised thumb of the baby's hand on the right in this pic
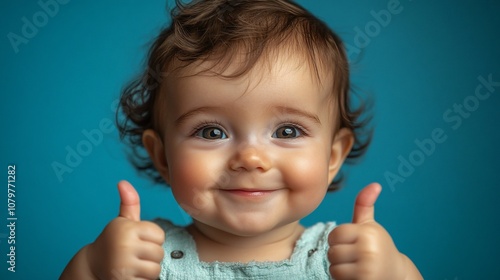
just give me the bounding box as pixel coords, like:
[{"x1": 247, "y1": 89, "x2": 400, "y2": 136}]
[{"x1": 352, "y1": 183, "x2": 382, "y2": 224}]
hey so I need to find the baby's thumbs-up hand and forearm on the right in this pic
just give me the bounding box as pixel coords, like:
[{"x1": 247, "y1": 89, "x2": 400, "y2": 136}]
[{"x1": 328, "y1": 184, "x2": 423, "y2": 280}]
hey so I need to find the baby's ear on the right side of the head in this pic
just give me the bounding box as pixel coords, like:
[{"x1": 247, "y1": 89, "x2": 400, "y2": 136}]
[{"x1": 328, "y1": 128, "x2": 354, "y2": 182}]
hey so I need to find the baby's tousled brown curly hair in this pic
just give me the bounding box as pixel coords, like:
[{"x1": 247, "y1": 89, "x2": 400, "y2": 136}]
[{"x1": 117, "y1": 0, "x2": 372, "y2": 190}]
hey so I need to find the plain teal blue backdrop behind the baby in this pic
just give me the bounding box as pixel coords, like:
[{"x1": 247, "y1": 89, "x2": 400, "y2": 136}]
[{"x1": 0, "y1": 0, "x2": 500, "y2": 279}]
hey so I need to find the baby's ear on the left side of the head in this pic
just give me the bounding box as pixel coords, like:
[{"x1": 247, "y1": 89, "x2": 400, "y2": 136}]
[{"x1": 142, "y1": 129, "x2": 170, "y2": 184}]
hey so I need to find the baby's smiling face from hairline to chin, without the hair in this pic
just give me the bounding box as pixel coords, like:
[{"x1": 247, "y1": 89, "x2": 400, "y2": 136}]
[{"x1": 155, "y1": 53, "x2": 350, "y2": 236}]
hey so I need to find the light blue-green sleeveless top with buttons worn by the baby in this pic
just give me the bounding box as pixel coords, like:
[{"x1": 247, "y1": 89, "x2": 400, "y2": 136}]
[{"x1": 155, "y1": 219, "x2": 335, "y2": 280}]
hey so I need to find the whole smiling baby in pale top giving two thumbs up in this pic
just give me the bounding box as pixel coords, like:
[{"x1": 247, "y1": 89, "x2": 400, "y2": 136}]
[{"x1": 61, "y1": 0, "x2": 422, "y2": 280}]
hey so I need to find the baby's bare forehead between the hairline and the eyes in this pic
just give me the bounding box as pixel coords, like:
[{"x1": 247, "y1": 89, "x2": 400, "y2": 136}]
[{"x1": 156, "y1": 52, "x2": 338, "y2": 131}]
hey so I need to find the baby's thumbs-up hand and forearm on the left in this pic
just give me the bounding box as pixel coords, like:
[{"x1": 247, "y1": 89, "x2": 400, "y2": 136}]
[{"x1": 87, "y1": 181, "x2": 165, "y2": 280}]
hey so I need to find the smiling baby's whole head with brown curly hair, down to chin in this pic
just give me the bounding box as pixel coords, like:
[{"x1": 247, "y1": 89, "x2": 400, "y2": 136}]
[{"x1": 119, "y1": 0, "x2": 369, "y2": 236}]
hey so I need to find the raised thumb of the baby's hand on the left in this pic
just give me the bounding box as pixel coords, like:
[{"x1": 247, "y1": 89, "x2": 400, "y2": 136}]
[{"x1": 118, "y1": 180, "x2": 141, "y2": 222}]
